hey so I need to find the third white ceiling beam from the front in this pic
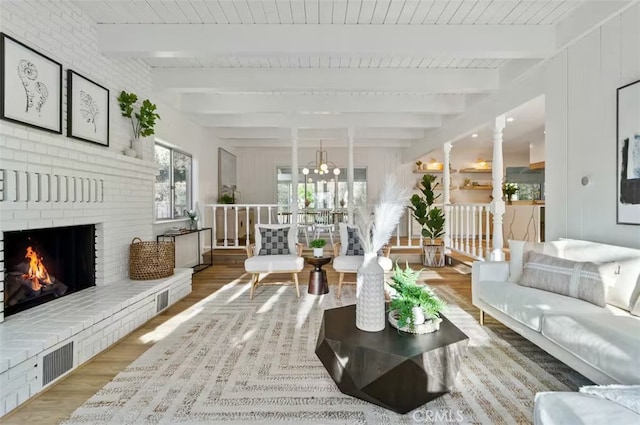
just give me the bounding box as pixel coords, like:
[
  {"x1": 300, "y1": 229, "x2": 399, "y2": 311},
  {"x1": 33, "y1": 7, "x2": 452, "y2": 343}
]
[{"x1": 179, "y1": 93, "x2": 465, "y2": 114}]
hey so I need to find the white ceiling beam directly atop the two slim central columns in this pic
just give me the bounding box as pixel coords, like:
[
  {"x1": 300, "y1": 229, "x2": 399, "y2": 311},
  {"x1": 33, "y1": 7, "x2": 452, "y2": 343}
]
[{"x1": 211, "y1": 127, "x2": 424, "y2": 139}]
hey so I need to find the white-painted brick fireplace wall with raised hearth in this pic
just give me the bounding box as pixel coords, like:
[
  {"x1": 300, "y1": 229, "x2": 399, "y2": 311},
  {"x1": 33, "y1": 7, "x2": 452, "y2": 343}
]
[{"x1": 0, "y1": 0, "x2": 192, "y2": 417}]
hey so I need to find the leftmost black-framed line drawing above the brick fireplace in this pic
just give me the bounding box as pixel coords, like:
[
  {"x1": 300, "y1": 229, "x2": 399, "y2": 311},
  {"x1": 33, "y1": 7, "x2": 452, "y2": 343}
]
[{"x1": 0, "y1": 33, "x2": 62, "y2": 133}]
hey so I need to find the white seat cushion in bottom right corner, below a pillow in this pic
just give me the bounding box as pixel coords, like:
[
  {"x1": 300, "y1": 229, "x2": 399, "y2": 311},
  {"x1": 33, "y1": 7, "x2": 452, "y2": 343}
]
[{"x1": 533, "y1": 392, "x2": 640, "y2": 425}]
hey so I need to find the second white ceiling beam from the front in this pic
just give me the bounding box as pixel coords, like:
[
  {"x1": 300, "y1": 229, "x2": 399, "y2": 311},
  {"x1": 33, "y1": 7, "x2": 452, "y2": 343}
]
[{"x1": 152, "y1": 68, "x2": 498, "y2": 94}]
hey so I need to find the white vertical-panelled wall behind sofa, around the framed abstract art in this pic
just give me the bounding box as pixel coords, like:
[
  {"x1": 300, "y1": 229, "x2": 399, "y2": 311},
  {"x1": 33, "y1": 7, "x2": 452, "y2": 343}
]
[{"x1": 545, "y1": 5, "x2": 640, "y2": 248}]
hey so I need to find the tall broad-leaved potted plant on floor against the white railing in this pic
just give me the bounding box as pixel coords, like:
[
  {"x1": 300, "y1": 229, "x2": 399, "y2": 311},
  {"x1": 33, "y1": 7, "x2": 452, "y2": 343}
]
[{"x1": 409, "y1": 174, "x2": 445, "y2": 267}]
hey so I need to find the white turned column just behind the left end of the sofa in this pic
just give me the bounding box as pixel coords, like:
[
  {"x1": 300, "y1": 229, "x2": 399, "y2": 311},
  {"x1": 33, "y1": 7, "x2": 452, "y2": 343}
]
[{"x1": 490, "y1": 115, "x2": 505, "y2": 261}]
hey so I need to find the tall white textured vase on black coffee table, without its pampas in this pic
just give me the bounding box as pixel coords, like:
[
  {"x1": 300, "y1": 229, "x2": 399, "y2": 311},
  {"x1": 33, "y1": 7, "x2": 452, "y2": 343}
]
[{"x1": 356, "y1": 252, "x2": 387, "y2": 332}]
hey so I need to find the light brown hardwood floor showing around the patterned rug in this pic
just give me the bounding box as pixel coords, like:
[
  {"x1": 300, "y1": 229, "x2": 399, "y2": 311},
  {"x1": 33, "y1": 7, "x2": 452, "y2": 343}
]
[{"x1": 0, "y1": 263, "x2": 471, "y2": 425}]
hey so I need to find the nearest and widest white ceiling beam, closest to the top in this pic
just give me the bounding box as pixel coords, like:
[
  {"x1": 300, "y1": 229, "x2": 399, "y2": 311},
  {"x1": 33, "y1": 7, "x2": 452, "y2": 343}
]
[{"x1": 97, "y1": 24, "x2": 555, "y2": 58}]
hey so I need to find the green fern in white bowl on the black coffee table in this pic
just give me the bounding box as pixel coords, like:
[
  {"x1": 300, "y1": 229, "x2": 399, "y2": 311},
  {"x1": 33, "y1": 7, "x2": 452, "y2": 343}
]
[{"x1": 389, "y1": 264, "x2": 447, "y2": 333}]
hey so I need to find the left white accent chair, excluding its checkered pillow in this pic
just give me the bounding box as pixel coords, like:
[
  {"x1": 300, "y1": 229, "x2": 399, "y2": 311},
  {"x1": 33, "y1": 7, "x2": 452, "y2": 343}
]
[{"x1": 244, "y1": 224, "x2": 304, "y2": 299}]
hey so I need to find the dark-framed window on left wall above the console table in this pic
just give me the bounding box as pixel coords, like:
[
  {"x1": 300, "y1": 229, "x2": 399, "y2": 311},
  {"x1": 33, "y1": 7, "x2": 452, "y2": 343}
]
[{"x1": 155, "y1": 143, "x2": 192, "y2": 220}]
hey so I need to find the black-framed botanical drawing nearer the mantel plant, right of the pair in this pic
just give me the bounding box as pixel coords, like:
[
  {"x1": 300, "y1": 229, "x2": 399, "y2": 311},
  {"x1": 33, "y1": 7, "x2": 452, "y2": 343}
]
[{"x1": 67, "y1": 69, "x2": 109, "y2": 146}]
